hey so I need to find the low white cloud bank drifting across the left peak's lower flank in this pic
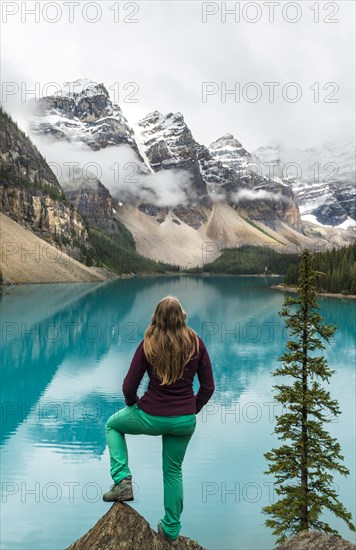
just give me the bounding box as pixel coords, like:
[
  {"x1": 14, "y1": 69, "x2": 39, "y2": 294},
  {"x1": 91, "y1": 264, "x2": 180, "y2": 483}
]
[{"x1": 27, "y1": 134, "x2": 195, "y2": 208}]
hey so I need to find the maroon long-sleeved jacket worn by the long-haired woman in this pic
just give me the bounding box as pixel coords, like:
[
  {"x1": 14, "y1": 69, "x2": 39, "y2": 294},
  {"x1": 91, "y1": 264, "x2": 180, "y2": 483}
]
[{"x1": 122, "y1": 336, "x2": 215, "y2": 416}]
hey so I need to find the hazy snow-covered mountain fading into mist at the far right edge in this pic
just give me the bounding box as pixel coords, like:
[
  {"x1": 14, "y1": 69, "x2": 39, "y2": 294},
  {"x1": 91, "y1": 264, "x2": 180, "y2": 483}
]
[{"x1": 253, "y1": 143, "x2": 356, "y2": 227}]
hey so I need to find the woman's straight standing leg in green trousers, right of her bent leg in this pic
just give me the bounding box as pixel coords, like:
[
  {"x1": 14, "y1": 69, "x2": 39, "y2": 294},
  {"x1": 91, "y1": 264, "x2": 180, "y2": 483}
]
[{"x1": 161, "y1": 416, "x2": 195, "y2": 539}]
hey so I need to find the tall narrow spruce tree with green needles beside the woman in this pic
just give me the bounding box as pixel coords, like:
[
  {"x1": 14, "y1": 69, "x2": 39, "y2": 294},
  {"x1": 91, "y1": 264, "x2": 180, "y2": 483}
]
[{"x1": 262, "y1": 249, "x2": 355, "y2": 543}]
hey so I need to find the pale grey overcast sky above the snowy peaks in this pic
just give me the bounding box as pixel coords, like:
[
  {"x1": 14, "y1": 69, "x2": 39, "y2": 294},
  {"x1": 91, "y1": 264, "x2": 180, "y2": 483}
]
[{"x1": 1, "y1": 0, "x2": 355, "y2": 150}]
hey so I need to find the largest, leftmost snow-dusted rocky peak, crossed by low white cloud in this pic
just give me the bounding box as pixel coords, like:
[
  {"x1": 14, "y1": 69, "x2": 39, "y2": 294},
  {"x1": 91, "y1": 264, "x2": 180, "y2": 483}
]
[{"x1": 29, "y1": 78, "x2": 148, "y2": 233}]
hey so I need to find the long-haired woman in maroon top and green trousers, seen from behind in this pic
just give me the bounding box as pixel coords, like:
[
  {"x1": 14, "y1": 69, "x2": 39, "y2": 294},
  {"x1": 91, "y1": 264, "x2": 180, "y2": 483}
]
[{"x1": 103, "y1": 296, "x2": 215, "y2": 542}]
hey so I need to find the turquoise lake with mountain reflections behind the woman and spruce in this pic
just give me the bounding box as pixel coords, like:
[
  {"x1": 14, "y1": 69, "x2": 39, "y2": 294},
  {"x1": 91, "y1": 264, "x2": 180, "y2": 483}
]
[{"x1": 0, "y1": 275, "x2": 356, "y2": 550}]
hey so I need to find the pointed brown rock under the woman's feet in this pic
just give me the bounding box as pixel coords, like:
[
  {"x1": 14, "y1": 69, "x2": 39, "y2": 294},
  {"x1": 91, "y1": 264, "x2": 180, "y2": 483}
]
[{"x1": 67, "y1": 502, "x2": 204, "y2": 550}]
